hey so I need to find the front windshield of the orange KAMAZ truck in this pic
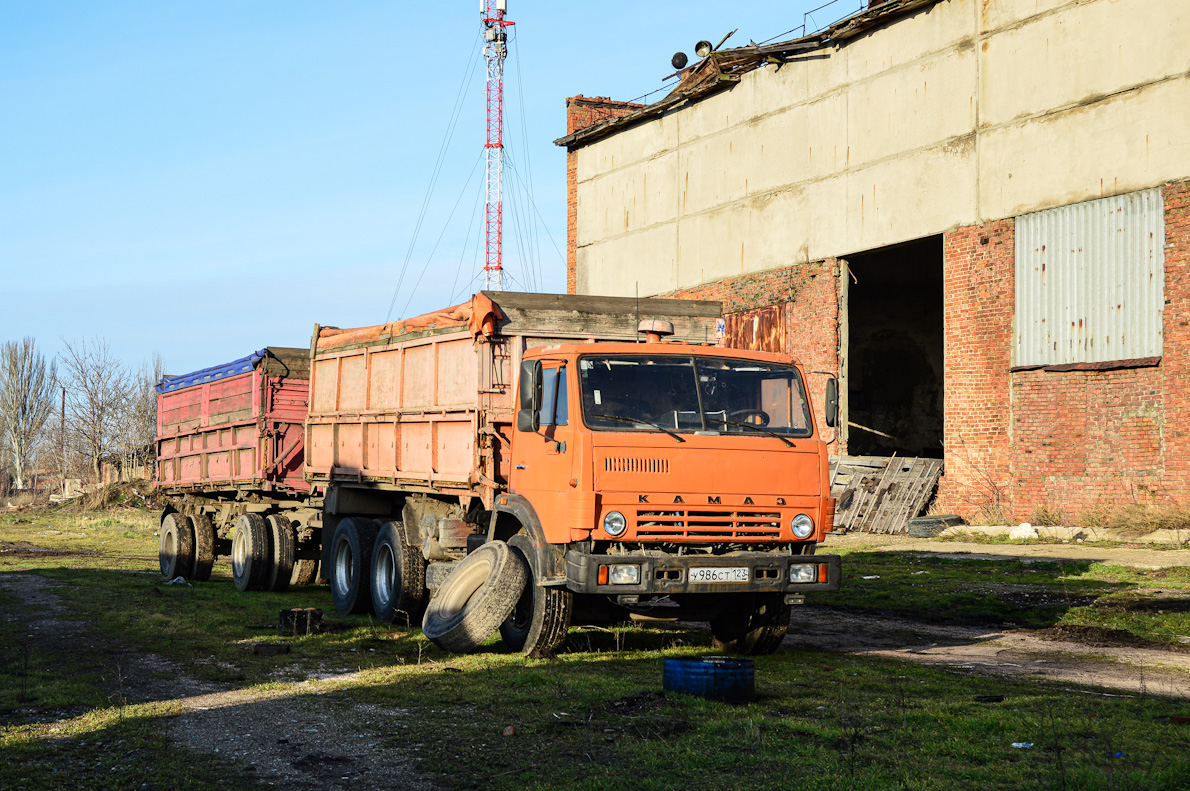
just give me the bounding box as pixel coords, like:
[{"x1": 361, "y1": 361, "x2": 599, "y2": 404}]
[{"x1": 578, "y1": 354, "x2": 812, "y2": 437}]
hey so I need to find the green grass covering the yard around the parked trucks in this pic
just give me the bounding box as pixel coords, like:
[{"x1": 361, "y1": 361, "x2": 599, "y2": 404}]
[{"x1": 0, "y1": 511, "x2": 1190, "y2": 791}]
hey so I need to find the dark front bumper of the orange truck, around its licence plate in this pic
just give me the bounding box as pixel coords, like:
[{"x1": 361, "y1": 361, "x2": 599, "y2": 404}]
[{"x1": 566, "y1": 551, "x2": 843, "y2": 595}]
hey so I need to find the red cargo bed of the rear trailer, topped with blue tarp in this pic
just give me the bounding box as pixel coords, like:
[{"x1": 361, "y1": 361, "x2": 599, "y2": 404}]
[{"x1": 157, "y1": 346, "x2": 309, "y2": 492}]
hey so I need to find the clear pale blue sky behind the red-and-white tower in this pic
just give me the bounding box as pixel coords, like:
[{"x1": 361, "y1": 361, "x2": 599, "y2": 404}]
[{"x1": 0, "y1": 0, "x2": 860, "y2": 372}]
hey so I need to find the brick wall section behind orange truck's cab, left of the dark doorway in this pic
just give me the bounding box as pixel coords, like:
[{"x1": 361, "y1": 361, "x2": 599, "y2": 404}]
[{"x1": 658, "y1": 258, "x2": 846, "y2": 440}]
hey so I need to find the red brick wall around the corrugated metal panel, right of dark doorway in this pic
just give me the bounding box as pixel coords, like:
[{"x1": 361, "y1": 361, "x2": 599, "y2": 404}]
[{"x1": 938, "y1": 183, "x2": 1190, "y2": 523}]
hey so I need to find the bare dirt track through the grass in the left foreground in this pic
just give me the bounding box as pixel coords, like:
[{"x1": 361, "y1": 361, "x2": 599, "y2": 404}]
[{"x1": 0, "y1": 573, "x2": 438, "y2": 791}]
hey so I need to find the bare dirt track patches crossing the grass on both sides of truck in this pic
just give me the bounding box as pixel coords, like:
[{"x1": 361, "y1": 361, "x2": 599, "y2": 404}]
[{"x1": 0, "y1": 535, "x2": 1190, "y2": 791}]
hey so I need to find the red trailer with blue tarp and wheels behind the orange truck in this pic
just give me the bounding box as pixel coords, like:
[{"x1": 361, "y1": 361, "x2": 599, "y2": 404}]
[{"x1": 156, "y1": 346, "x2": 319, "y2": 590}]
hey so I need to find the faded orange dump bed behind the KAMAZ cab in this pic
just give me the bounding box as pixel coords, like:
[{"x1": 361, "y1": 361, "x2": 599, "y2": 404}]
[{"x1": 306, "y1": 291, "x2": 721, "y2": 508}]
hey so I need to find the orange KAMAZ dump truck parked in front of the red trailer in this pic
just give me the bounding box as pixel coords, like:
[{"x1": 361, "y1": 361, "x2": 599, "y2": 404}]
[{"x1": 306, "y1": 293, "x2": 840, "y2": 653}]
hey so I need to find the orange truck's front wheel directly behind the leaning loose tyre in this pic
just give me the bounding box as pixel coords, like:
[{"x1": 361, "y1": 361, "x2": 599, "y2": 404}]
[{"x1": 500, "y1": 533, "x2": 575, "y2": 654}]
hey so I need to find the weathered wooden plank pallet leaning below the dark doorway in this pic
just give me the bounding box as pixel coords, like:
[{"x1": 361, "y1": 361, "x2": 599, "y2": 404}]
[{"x1": 831, "y1": 456, "x2": 942, "y2": 533}]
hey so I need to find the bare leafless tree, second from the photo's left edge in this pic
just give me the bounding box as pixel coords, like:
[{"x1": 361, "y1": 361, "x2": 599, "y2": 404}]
[{"x1": 62, "y1": 339, "x2": 131, "y2": 482}]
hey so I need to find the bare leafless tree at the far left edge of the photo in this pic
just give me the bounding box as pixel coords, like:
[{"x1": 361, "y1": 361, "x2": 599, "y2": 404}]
[{"x1": 0, "y1": 338, "x2": 57, "y2": 489}]
